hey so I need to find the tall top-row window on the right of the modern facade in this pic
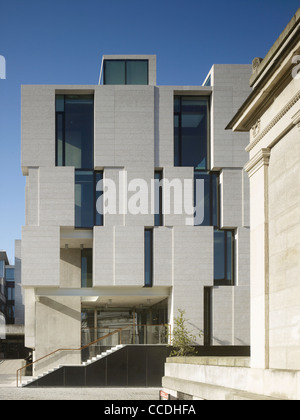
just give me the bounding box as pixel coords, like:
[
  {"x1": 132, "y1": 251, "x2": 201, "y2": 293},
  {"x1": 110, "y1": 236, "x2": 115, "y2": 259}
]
[{"x1": 174, "y1": 96, "x2": 210, "y2": 170}]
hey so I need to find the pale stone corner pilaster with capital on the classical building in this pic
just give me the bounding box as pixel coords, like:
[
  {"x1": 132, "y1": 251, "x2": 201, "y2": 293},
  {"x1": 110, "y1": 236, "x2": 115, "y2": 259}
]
[{"x1": 245, "y1": 149, "x2": 271, "y2": 369}]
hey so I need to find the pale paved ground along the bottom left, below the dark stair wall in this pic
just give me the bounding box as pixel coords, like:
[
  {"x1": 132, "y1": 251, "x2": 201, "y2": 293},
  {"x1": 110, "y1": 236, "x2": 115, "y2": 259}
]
[{"x1": 0, "y1": 375, "x2": 159, "y2": 401}]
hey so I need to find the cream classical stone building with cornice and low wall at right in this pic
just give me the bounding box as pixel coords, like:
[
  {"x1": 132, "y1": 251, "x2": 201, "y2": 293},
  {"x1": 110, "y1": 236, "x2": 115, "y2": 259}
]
[{"x1": 164, "y1": 9, "x2": 300, "y2": 400}]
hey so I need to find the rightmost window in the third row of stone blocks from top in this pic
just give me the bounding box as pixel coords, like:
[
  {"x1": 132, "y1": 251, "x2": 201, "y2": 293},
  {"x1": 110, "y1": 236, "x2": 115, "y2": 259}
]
[{"x1": 214, "y1": 230, "x2": 234, "y2": 286}]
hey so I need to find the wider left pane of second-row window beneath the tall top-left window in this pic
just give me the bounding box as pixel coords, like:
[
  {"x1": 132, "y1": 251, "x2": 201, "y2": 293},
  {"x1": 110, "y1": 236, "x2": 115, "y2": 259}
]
[{"x1": 75, "y1": 171, "x2": 94, "y2": 228}]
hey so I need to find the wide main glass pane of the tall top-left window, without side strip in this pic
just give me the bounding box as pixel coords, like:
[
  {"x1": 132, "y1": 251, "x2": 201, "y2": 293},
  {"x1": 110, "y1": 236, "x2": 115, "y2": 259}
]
[{"x1": 65, "y1": 96, "x2": 94, "y2": 169}]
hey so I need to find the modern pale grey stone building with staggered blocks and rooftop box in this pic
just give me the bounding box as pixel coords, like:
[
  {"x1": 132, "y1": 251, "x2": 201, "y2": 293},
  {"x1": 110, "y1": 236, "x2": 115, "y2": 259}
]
[{"x1": 22, "y1": 56, "x2": 251, "y2": 374}]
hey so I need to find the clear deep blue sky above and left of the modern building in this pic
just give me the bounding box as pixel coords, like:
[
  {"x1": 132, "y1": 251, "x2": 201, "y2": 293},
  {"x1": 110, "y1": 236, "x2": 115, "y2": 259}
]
[{"x1": 0, "y1": 0, "x2": 299, "y2": 262}]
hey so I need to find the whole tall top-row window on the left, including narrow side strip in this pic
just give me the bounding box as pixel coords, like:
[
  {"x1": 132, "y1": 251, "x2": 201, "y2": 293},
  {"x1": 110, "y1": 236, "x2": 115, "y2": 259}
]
[{"x1": 56, "y1": 95, "x2": 94, "y2": 169}]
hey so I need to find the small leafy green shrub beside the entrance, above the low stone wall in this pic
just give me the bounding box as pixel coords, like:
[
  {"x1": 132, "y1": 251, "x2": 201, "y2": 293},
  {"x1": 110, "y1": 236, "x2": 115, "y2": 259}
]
[{"x1": 170, "y1": 309, "x2": 197, "y2": 357}]
